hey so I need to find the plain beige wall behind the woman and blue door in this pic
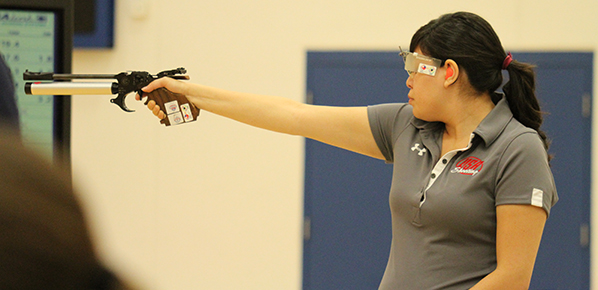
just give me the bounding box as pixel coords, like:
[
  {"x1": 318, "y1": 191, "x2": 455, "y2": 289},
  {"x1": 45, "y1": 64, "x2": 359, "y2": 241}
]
[{"x1": 72, "y1": 0, "x2": 598, "y2": 290}]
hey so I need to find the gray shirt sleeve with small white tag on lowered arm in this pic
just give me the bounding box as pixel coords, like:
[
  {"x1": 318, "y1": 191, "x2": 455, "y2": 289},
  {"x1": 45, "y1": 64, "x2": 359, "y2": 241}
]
[{"x1": 495, "y1": 132, "x2": 558, "y2": 214}]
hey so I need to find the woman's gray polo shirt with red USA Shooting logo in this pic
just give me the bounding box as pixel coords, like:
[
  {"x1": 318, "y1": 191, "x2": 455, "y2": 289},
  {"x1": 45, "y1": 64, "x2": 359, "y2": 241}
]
[{"x1": 368, "y1": 97, "x2": 558, "y2": 290}]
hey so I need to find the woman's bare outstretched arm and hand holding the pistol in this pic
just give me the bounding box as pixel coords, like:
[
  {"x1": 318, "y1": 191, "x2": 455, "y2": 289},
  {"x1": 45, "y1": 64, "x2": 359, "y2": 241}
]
[{"x1": 143, "y1": 78, "x2": 384, "y2": 159}]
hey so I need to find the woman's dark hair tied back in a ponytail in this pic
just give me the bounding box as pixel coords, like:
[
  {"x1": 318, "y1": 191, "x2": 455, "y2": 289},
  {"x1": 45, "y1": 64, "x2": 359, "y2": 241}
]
[{"x1": 410, "y1": 12, "x2": 550, "y2": 160}]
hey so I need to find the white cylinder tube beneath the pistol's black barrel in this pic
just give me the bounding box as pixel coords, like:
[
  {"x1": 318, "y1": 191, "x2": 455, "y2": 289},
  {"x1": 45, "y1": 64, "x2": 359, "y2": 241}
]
[{"x1": 25, "y1": 82, "x2": 118, "y2": 95}]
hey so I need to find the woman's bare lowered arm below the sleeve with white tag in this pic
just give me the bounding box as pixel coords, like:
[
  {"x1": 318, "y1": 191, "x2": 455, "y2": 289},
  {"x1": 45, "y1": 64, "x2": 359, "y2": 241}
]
[{"x1": 471, "y1": 205, "x2": 546, "y2": 290}]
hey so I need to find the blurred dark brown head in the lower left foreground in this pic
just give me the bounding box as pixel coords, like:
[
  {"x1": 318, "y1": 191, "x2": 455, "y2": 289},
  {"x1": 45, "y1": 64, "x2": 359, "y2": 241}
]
[{"x1": 0, "y1": 128, "x2": 135, "y2": 290}]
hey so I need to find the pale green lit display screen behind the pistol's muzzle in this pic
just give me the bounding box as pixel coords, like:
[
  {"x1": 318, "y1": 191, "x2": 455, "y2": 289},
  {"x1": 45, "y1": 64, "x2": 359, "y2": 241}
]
[{"x1": 0, "y1": 9, "x2": 56, "y2": 159}]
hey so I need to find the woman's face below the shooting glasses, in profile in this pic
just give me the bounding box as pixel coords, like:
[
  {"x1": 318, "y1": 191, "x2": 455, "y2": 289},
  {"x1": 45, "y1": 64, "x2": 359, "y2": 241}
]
[{"x1": 406, "y1": 48, "x2": 444, "y2": 122}]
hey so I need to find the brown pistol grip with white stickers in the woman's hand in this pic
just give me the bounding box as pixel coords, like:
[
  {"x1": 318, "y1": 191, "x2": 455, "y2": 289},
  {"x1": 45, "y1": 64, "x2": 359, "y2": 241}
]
[{"x1": 145, "y1": 88, "x2": 199, "y2": 126}]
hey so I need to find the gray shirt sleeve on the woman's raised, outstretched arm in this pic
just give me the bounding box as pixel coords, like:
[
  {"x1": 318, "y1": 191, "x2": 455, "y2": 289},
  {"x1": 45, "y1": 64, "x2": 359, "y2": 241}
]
[{"x1": 368, "y1": 103, "x2": 413, "y2": 163}]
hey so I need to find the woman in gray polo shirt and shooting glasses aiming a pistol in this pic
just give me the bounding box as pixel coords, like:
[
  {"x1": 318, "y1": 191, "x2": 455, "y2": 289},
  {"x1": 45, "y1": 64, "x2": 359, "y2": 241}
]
[{"x1": 143, "y1": 12, "x2": 558, "y2": 289}]
